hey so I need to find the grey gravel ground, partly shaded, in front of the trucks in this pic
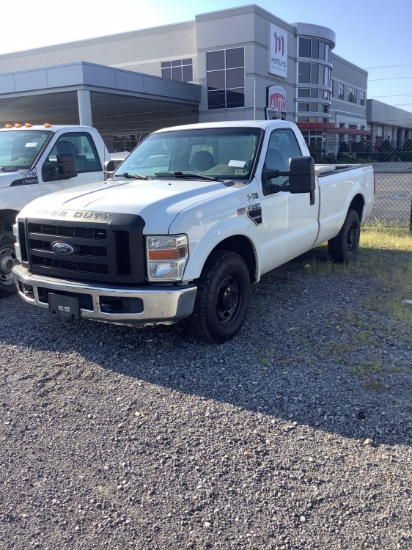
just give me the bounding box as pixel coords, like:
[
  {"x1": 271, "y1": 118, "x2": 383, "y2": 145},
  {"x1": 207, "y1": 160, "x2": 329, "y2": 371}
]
[{"x1": 0, "y1": 261, "x2": 412, "y2": 550}]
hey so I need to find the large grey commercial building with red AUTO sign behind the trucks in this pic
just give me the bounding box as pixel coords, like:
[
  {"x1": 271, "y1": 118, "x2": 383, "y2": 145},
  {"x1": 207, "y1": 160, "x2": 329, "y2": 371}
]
[{"x1": 0, "y1": 5, "x2": 411, "y2": 154}]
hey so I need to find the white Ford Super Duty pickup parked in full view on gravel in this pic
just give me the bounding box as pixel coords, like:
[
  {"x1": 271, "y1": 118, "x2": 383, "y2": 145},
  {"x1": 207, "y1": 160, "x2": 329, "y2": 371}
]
[{"x1": 13, "y1": 121, "x2": 374, "y2": 343}]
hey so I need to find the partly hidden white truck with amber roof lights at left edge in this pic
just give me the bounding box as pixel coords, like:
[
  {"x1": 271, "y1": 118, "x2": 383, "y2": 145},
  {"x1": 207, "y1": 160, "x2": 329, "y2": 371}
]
[{"x1": 0, "y1": 124, "x2": 110, "y2": 296}]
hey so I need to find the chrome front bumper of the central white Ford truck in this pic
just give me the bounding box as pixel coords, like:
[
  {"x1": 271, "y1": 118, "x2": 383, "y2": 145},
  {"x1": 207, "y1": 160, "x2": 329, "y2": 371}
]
[{"x1": 13, "y1": 265, "x2": 197, "y2": 325}]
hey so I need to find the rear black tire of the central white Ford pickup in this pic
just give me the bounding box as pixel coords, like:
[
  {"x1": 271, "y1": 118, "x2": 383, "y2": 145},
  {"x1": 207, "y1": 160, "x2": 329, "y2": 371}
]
[{"x1": 328, "y1": 210, "x2": 360, "y2": 264}]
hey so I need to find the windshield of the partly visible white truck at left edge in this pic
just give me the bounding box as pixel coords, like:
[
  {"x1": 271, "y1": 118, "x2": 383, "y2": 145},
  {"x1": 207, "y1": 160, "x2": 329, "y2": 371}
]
[{"x1": 0, "y1": 129, "x2": 51, "y2": 172}]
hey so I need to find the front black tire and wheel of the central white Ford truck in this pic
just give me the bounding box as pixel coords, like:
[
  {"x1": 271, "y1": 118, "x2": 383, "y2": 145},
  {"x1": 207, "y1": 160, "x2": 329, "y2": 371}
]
[{"x1": 188, "y1": 250, "x2": 251, "y2": 344}]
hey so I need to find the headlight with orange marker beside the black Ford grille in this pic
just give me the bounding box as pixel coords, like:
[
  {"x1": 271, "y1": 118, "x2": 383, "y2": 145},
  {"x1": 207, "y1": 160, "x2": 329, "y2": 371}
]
[{"x1": 146, "y1": 235, "x2": 189, "y2": 281}]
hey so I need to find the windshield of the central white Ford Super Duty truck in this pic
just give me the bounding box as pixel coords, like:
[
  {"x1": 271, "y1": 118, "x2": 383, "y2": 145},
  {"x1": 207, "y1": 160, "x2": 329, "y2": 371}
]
[{"x1": 114, "y1": 128, "x2": 262, "y2": 179}]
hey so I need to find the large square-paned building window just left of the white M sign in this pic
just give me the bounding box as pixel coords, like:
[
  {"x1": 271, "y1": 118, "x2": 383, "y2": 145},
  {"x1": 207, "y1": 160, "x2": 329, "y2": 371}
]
[{"x1": 206, "y1": 48, "x2": 245, "y2": 109}]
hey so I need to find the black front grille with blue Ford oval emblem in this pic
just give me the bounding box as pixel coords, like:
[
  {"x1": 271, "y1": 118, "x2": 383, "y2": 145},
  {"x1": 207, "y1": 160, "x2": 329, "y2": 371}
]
[{"x1": 18, "y1": 210, "x2": 146, "y2": 284}]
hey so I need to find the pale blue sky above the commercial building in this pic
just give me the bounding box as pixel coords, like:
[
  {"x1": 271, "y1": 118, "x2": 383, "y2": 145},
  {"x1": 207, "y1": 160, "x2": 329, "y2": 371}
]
[{"x1": 0, "y1": 0, "x2": 412, "y2": 113}]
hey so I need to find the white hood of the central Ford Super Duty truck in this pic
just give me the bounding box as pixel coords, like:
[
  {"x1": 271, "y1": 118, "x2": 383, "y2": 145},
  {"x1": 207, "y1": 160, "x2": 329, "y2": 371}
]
[{"x1": 21, "y1": 179, "x2": 238, "y2": 232}]
